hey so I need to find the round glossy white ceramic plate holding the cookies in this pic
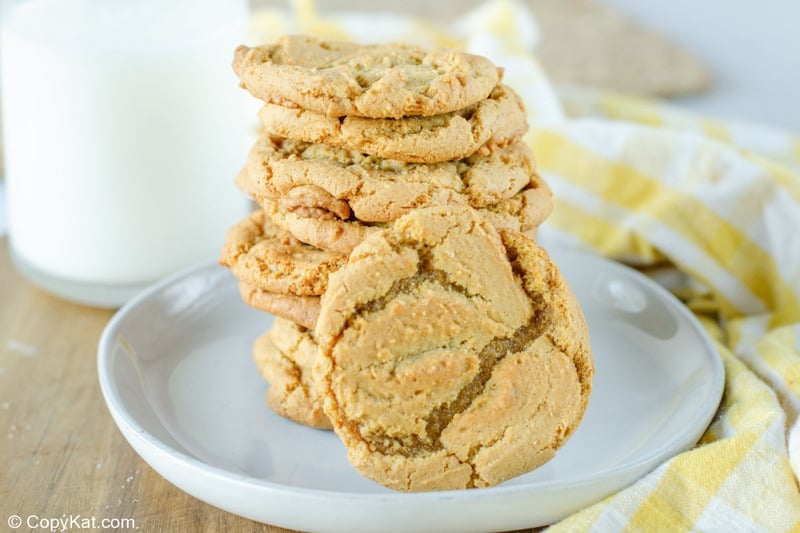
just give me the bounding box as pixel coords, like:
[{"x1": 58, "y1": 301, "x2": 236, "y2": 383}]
[{"x1": 98, "y1": 247, "x2": 724, "y2": 532}]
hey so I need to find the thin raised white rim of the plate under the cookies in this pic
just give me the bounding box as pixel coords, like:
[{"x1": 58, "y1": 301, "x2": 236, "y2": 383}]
[{"x1": 97, "y1": 245, "x2": 725, "y2": 520}]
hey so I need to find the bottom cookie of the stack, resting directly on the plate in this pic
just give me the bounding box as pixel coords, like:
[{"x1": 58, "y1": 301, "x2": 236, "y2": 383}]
[{"x1": 253, "y1": 318, "x2": 332, "y2": 429}]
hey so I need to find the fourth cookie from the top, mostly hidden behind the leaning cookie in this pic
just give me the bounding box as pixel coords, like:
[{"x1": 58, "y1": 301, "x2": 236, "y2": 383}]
[{"x1": 262, "y1": 181, "x2": 553, "y2": 254}]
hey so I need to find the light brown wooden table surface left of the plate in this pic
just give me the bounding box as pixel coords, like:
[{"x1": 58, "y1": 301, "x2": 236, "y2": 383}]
[{"x1": 0, "y1": 238, "x2": 287, "y2": 532}]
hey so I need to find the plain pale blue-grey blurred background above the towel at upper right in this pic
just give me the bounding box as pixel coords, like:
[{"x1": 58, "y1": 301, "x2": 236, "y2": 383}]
[{"x1": 0, "y1": 0, "x2": 800, "y2": 235}]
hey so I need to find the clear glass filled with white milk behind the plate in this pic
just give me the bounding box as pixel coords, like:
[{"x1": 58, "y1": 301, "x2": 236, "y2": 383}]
[{"x1": 0, "y1": 0, "x2": 250, "y2": 307}]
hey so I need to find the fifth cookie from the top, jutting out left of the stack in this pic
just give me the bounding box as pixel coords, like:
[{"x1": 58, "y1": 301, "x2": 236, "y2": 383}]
[{"x1": 220, "y1": 210, "x2": 347, "y2": 296}]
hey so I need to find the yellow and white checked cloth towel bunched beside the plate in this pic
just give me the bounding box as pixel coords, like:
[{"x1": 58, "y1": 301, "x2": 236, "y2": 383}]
[{"x1": 253, "y1": 0, "x2": 800, "y2": 532}]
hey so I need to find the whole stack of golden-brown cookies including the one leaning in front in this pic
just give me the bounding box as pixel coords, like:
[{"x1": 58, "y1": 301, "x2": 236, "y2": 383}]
[{"x1": 220, "y1": 36, "x2": 592, "y2": 490}]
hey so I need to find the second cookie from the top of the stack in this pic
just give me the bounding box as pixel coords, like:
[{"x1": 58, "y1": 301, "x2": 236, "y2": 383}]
[{"x1": 259, "y1": 85, "x2": 528, "y2": 163}]
